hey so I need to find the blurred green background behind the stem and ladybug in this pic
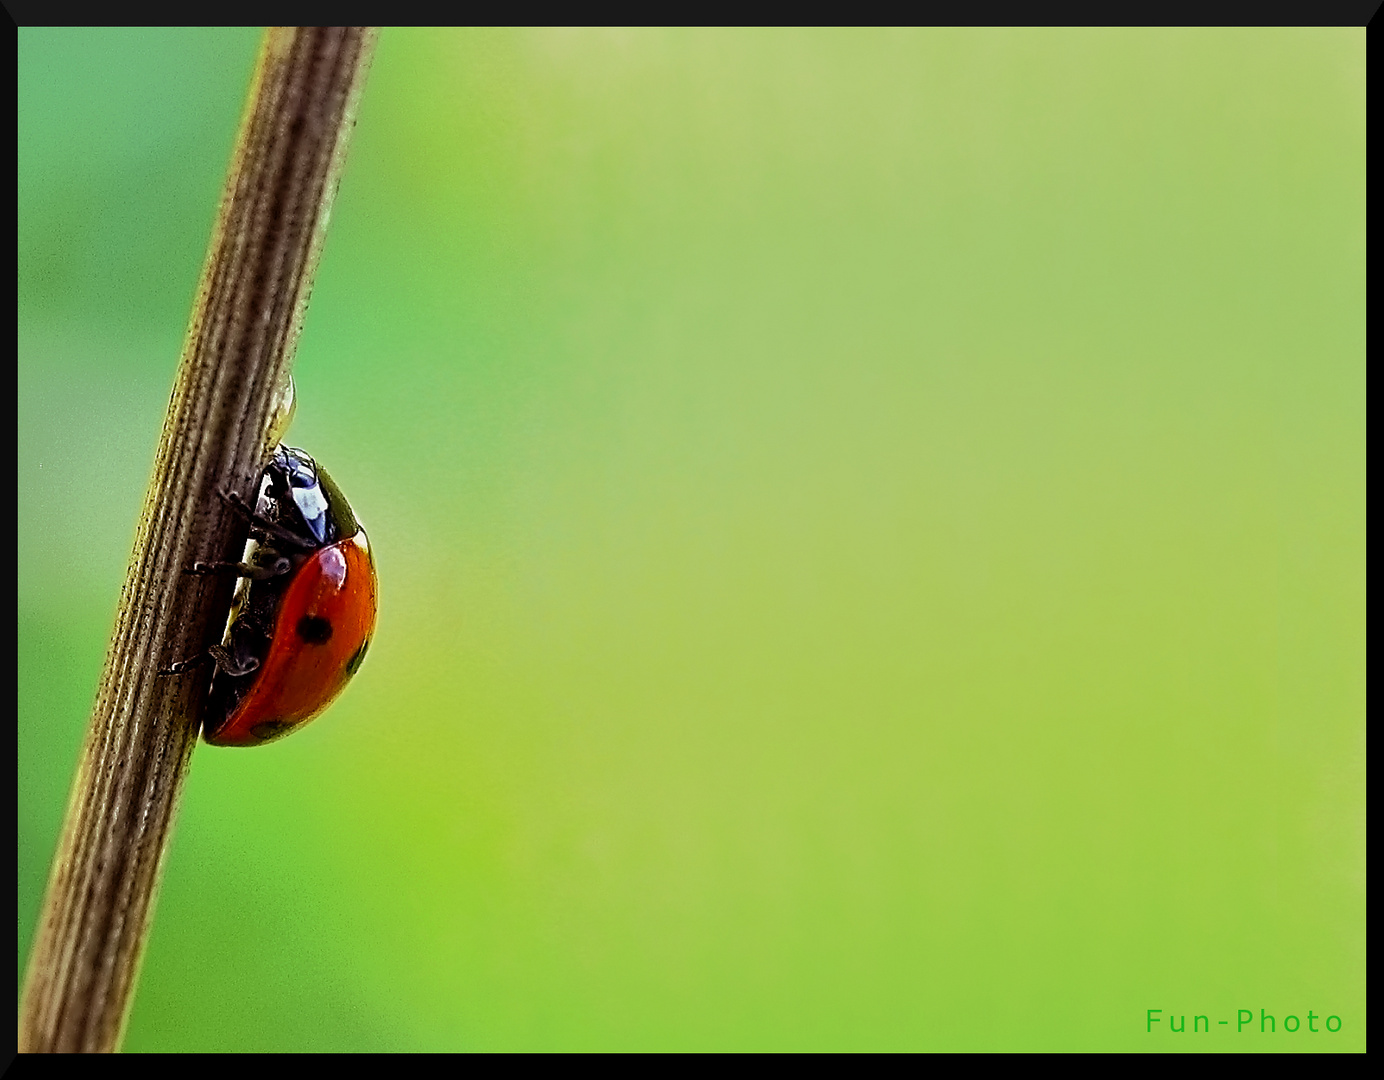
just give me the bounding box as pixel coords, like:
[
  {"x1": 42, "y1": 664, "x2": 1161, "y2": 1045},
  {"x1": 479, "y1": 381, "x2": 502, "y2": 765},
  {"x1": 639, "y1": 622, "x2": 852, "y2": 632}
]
[{"x1": 18, "y1": 29, "x2": 1365, "y2": 1050}]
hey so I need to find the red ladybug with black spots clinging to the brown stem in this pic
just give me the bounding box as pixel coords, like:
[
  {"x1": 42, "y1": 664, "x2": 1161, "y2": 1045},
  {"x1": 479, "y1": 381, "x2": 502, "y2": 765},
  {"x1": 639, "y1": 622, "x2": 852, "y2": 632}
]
[{"x1": 192, "y1": 446, "x2": 376, "y2": 746}]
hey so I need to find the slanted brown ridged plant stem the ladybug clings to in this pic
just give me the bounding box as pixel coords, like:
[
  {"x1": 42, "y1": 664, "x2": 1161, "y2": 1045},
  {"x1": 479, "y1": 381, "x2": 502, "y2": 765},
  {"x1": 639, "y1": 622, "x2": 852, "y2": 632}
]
[{"x1": 19, "y1": 26, "x2": 376, "y2": 1051}]
